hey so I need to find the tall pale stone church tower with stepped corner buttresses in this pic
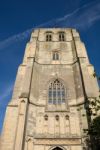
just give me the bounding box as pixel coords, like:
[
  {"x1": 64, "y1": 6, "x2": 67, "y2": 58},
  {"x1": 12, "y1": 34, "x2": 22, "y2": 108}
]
[{"x1": 0, "y1": 28, "x2": 98, "y2": 150}]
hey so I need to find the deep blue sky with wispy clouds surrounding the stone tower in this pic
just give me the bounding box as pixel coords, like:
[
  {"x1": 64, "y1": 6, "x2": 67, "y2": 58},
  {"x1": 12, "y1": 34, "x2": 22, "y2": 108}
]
[{"x1": 0, "y1": 0, "x2": 100, "y2": 132}]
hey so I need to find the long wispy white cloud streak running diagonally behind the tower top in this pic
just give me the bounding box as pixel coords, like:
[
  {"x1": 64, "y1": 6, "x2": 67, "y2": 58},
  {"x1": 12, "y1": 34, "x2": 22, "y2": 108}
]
[{"x1": 0, "y1": 0, "x2": 100, "y2": 49}]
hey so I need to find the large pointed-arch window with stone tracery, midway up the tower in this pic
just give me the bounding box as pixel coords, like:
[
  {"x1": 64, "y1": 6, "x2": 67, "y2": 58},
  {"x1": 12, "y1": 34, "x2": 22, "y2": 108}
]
[{"x1": 48, "y1": 79, "x2": 65, "y2": 104}]
